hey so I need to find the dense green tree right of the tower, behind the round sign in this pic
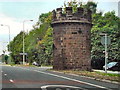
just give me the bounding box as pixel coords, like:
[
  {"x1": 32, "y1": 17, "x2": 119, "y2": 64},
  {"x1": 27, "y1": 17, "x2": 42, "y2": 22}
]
[{"x1": 91, "y1": 11, "x2": 120, "y2": 68}]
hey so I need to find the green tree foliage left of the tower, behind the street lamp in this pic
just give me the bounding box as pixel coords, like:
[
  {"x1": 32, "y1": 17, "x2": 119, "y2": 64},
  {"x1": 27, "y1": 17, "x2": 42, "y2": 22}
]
[{"x1": 10, "y1": 12, "x2": 52, "y2": 64}]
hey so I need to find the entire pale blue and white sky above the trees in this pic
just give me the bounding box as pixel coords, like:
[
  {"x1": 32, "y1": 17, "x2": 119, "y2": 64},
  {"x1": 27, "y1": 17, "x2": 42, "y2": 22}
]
[{"x1": 0, "y1": 0, "x2": 119, "y2": 55}]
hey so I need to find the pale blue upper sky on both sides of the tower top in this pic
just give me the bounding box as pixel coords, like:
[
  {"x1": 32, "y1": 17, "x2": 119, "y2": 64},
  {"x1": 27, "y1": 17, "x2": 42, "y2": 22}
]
[{"x1": 0, "y1": 0, "x2": 118, "y2": 21}]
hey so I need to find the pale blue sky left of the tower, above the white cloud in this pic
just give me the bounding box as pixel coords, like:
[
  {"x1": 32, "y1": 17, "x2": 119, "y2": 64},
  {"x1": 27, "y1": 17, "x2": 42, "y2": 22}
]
[{"x1": 0, "y1": 2, "x2": 61, "y2": 19}]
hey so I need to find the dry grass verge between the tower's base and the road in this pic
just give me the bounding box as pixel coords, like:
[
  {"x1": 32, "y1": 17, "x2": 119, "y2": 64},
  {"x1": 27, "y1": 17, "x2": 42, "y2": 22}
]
[{"x1": 50, "y1": 69, "x2": 120, "y2": 83}]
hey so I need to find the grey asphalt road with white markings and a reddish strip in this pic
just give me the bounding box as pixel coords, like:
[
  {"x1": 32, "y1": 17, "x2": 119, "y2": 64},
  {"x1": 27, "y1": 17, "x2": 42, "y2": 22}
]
[{"x1": 1, "y1": 65, "x2": 119, "y2": 90}]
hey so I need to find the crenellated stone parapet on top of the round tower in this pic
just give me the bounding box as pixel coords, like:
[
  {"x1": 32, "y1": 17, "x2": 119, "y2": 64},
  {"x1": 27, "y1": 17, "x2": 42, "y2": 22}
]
[{"x1": 52, "y1": 7, "x2": 92, "y2": 23}]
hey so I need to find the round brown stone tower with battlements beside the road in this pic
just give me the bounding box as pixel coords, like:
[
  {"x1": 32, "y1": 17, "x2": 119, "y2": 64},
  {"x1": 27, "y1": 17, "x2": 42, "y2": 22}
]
[{"x1": 51, "y1": 7, "x2": 92, "y2": 71}]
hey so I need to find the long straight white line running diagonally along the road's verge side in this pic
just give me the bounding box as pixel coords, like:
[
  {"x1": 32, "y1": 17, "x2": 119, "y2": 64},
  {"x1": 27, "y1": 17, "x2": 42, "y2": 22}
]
[{"x1": 19, "y1": 67, "x2": 112, "y2": 90}]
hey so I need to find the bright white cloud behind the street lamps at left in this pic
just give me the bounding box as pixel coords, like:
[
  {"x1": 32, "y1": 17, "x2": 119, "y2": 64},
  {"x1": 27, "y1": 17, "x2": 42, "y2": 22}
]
[{"x1": 0, "y1": 14, "x2": 32, "y2": 36}]
